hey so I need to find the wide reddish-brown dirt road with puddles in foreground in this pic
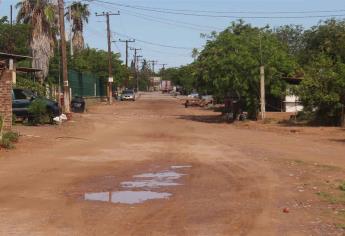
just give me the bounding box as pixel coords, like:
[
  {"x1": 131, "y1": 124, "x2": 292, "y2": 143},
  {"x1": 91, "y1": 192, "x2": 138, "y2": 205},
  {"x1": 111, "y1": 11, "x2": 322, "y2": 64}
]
[{"x1": 0, "y1": 94, "x2": 345, "y2": 235}]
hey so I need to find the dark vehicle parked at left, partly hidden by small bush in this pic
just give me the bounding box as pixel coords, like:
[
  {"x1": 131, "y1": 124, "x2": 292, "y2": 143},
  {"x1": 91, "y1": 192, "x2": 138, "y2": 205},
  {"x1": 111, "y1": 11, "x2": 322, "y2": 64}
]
[{"x1": 12, "y1": 89, "x2": 62, "y2": 119}]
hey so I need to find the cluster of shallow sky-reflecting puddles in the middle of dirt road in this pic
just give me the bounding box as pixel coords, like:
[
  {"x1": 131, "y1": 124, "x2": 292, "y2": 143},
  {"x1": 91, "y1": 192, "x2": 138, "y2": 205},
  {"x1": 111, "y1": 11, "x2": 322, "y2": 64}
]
[{"x1": 84, "y1": 165, "x2": 192, "y2": 204}]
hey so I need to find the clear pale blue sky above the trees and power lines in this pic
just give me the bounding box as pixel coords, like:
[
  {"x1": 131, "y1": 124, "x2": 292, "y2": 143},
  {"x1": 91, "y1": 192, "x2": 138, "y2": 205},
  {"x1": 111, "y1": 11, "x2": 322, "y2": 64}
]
[{"x1": 0, "y1": 0, "x2": 345, "y2": 70}]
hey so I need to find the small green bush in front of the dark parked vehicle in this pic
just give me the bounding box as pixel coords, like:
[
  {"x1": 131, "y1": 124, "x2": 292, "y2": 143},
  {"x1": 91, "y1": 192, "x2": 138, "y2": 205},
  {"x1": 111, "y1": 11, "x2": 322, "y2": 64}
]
[{"x1": 28, "y1": 99, "x2": 50, "y2": 125}]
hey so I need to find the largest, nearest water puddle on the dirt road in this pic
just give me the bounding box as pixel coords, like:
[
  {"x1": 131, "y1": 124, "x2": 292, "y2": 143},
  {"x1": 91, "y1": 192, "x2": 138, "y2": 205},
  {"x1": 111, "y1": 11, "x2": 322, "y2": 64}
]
[{"x1": 84, "y1": 191, "x2": 172, "y2": 204}]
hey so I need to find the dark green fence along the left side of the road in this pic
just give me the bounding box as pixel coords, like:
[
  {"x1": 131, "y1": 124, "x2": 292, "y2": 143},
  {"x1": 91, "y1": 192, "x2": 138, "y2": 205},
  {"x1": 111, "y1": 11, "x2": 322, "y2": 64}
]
[{"x1": 68, "y1": 70, "x2": 107, "y2": 97}]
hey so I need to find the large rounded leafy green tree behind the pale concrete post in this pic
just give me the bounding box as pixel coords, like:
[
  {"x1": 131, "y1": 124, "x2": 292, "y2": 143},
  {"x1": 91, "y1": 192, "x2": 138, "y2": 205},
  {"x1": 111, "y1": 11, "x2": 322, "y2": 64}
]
[{"x1": 195, "y1": 21, "x2": 297, "y2": 118}]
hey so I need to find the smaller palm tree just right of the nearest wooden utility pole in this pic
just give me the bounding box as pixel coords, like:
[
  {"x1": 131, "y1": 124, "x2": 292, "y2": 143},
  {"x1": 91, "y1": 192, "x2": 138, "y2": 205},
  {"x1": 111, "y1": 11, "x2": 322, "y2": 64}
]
[{"x1": 66, "y1": 2, "x2": 90, "y2": 52}]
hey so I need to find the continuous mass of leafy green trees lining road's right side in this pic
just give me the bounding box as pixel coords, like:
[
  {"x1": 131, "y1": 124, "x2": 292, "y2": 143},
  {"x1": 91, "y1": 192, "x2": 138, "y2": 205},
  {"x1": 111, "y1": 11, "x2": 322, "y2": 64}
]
[{"x1": 164, "y1": 19, "x2": 345, "y2": 125}]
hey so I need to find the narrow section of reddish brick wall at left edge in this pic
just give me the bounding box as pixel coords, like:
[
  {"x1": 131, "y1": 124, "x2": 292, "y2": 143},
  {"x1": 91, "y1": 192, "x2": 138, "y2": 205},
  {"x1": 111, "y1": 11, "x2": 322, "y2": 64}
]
[{"x1": 0, "y1": 70, "x2": 12, "y2": 131}]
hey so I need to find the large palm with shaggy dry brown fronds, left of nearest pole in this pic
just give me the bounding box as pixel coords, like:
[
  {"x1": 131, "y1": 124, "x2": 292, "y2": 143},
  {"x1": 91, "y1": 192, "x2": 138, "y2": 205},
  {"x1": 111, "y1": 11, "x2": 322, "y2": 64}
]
[{"x1": 16, "y1": 0, "x2": 57, "y2": 83}]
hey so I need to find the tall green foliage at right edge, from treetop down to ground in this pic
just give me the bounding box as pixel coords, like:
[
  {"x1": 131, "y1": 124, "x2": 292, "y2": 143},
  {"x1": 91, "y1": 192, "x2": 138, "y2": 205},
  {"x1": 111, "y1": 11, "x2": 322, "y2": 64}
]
[{"x1": 298, "y1": 19, "x2": 345, "y2": 125}]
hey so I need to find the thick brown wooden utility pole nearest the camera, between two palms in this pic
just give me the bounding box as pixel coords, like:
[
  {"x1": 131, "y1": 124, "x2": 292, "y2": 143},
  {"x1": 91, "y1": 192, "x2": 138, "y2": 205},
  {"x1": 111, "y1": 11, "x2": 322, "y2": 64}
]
[{"x1": 58, "y1": 0, "x2": 71, "y2": 114}]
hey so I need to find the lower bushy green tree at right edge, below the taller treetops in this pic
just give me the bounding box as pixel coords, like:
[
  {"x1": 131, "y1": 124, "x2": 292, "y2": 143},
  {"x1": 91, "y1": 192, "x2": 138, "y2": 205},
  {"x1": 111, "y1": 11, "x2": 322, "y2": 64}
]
[{"x1": 299, "y1": 54, "x2": 345, "y2": 125}]
